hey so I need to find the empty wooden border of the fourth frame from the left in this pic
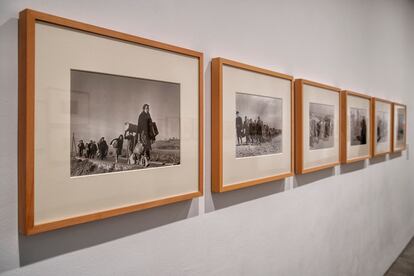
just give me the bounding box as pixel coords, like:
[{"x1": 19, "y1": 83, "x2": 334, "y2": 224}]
[{"x1": 340, "y1": 90, "x2": 372, "y2": 164}]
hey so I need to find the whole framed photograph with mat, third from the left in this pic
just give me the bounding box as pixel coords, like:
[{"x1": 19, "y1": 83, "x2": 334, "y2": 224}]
[{"x1": 295, "y1": 79, "x2": 341, "y2": 174}]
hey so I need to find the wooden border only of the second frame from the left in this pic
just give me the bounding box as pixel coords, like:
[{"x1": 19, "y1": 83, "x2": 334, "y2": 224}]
[{"x1": 211, "y1": 57, "x2": 294, "y2": 193}]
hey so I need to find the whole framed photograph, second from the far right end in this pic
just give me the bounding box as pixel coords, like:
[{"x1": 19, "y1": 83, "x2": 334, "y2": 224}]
[{"x1": 371, "y1": 98, "x2": 392, "y2": 156}]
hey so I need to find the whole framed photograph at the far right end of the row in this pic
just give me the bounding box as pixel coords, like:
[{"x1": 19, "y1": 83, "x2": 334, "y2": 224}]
[{"x1": 392, "y1": 103, "x2": 407, "y2": 152}]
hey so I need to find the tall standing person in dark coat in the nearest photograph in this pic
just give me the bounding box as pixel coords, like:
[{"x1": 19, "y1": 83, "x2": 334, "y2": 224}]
[{"x1": 137, "y1": 104, "x2": 155, "y2": 163}]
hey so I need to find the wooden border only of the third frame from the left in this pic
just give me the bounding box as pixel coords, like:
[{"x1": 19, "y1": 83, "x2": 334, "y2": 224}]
[{"x1": 295, "y1": 79, "x2": 341, "y2": 174}]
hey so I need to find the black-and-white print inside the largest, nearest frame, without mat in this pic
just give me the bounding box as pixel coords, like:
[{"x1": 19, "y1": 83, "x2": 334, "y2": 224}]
[{"x1": 70, "y1": 70, "x2": 180, "y2": 176}]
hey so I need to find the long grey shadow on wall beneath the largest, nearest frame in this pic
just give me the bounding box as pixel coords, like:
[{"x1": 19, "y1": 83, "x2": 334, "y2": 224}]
[{"x1": 19, "y1": 199, "x2": 199, "y2": 266}]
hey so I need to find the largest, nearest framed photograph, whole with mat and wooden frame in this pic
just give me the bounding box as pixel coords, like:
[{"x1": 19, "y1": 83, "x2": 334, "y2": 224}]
[{"x1": 19, "y1": 10, "x2": 203, "y2": 235}]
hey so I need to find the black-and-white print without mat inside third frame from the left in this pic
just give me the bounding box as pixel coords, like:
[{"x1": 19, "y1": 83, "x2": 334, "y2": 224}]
[{"x1": 309, "y1": 103, "x2": 335, "y2": 150}]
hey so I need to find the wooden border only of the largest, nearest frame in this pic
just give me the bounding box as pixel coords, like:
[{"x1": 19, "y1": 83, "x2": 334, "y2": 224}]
[{"x1": 18, "y1": 9, "x2": 204, "y2": 235}]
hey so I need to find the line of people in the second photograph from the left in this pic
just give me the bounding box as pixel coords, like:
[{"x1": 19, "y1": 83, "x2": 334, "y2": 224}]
[{"x1": 236, "y1": 111, "x2": 277, "y2": 145}]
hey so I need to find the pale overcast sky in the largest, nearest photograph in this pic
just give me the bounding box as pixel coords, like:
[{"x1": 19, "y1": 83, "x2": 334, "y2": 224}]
[{"x1": 71, "y1": 70, "x2": 180, "y2": 142}]
